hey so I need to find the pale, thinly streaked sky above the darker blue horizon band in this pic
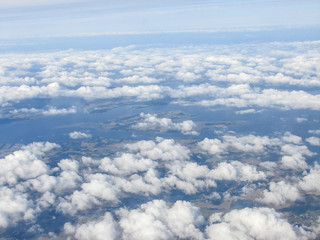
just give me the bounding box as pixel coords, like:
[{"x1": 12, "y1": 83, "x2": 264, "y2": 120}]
[{"x1": 0, "y1": 0, "x2": 320, "y2": 39}]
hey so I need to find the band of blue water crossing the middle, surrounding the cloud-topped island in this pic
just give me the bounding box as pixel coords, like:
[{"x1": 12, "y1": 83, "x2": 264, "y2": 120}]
[{"x1": 0, "y1": 95, "x2": 320, "y2": 144}]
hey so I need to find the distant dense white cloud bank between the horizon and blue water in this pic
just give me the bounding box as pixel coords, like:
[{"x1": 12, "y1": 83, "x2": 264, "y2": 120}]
[{"x1": 0, "y1": 41, "x2": 320, "y2": 111}]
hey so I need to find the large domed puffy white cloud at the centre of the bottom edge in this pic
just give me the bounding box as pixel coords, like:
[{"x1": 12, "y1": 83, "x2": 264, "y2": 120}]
[{"x1": 118, "y1": 200, "x2": 204, "y2": 239}]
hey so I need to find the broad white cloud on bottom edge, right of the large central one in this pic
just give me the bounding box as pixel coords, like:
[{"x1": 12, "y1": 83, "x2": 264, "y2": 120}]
[{"x1": 206, "y1": 208, "x2": 314, "y2": 240}]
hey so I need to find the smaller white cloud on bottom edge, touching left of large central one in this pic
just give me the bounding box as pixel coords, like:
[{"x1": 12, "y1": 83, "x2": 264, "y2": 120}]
[{"x1": 64, "y1": 213, "x2": 119, "y2": 240}]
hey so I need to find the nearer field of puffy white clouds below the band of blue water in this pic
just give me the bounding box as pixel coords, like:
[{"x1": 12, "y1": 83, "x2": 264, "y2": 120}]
[{"x1": 0, "y1": 128, "x2": 320, "y2": 239}]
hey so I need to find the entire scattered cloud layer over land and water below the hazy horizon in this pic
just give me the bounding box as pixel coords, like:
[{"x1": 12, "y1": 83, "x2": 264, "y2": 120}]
[{"x1": 0, "y1": 41, "x2": 320, "y2": 239}]
